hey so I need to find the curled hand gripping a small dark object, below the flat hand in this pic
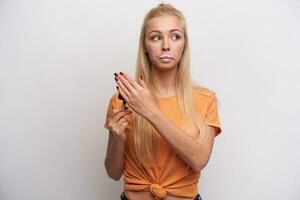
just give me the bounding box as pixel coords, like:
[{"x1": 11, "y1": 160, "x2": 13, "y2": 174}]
[{"x1": 108, "y1": 107, "x2": 131, "y2": 141}]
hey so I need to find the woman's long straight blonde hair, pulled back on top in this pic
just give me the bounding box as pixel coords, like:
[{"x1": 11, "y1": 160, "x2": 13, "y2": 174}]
[{"x1": 133, "y1": 4, "x2": 206, "y2": 166}]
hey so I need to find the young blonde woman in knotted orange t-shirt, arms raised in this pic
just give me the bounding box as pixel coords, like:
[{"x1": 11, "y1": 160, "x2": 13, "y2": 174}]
[{"x1": 105, "y1": 4, "x2": 221, "y2": 200}]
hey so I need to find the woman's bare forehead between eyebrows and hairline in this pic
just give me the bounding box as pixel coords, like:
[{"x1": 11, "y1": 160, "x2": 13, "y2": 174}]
[{"x1": 146, "y1": 15, "x2": 183, "y2": 33}]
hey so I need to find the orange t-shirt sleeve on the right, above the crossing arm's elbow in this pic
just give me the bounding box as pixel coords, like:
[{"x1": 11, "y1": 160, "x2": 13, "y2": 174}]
[{"x1": 204, "y1": 93, "x2": 222, "y2": 136}]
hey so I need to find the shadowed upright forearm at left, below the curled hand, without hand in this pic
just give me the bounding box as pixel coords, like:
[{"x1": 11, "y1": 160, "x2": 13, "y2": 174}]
[{"x1": 105, "y1": 137, "x2": 125, "y2": 180}]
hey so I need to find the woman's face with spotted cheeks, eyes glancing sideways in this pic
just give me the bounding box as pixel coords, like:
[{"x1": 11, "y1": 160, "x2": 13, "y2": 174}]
[{"x1": 145, "y1": 16, "x2": 185, "y2": 71}]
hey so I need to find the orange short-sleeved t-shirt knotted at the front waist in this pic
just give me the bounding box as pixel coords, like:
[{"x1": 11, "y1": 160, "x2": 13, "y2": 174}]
[{"x1": 104, "y1": 87, "x2": 221, "y2": 199}]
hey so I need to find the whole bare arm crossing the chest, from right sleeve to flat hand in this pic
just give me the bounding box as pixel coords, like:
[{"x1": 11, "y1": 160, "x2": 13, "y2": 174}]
[{"x1": 116, "y1": 73, "x2": 216, "y2": 171}]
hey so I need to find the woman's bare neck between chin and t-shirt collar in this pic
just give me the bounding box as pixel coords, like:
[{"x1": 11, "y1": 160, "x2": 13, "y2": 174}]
[{"x1": 152, "y1": 67, "x2": 177, "y2": 97}]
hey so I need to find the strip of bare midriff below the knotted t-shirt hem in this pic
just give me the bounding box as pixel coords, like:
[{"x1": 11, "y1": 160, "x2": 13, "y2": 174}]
[{"x1": 124, "y1": 191, "x2": 194, "y2": 200}]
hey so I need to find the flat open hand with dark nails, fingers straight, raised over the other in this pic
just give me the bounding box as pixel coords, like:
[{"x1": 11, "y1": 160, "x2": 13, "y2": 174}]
[{"x1": 115, "y1": 72, "x2": 159, "y2": 119}]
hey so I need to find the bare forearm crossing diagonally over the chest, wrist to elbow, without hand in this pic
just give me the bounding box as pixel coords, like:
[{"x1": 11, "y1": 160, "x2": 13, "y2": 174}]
[{"x1": 148, "y1": 111, "x2": 211, "y2": 171}]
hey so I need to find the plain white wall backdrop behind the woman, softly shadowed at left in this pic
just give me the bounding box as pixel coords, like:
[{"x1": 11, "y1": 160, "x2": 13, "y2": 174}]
[{"x1": 0, "y1": 0, "x2": 300, "y2": 200}]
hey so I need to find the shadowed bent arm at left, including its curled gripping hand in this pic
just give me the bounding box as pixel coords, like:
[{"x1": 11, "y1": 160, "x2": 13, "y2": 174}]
[{"x1": 105, "y1": 107, "x2": 129, "y2": 181}]
